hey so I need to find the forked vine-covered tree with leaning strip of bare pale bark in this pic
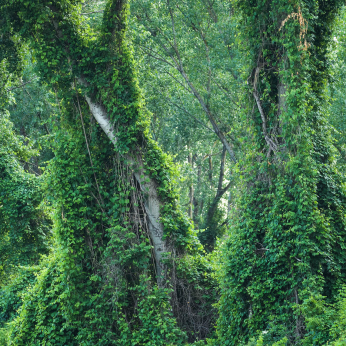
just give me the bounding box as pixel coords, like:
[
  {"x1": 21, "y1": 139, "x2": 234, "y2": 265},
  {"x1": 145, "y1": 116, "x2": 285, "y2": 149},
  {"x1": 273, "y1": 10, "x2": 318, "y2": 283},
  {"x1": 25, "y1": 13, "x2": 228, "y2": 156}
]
[{"x1": 0, "y1": 0, "x2": 219, "y2": 346}]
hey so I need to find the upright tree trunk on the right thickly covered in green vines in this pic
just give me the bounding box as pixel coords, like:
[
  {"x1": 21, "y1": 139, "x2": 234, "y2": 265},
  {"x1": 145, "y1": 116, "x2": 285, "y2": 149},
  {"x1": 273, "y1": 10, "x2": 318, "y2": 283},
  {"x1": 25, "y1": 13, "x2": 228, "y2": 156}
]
[{"x1": 218, "y1": 0, "x2": 346, "y2": 346}]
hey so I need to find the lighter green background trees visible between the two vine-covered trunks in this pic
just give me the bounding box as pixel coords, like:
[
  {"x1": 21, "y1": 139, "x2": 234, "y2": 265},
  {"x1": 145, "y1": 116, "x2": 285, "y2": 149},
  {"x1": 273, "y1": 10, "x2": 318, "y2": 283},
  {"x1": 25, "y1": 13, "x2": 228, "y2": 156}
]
[{"x1": 130, "y1": 0, "x2": 243, "y2": 248}]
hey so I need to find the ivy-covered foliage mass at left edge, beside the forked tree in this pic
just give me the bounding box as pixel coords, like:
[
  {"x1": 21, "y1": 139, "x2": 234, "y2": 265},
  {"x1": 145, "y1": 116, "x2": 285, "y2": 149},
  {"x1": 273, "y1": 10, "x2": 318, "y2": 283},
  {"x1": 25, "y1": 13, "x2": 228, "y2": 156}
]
[{"x1": 0, "y1": 112, "x2": 50, "y2": 283}]
